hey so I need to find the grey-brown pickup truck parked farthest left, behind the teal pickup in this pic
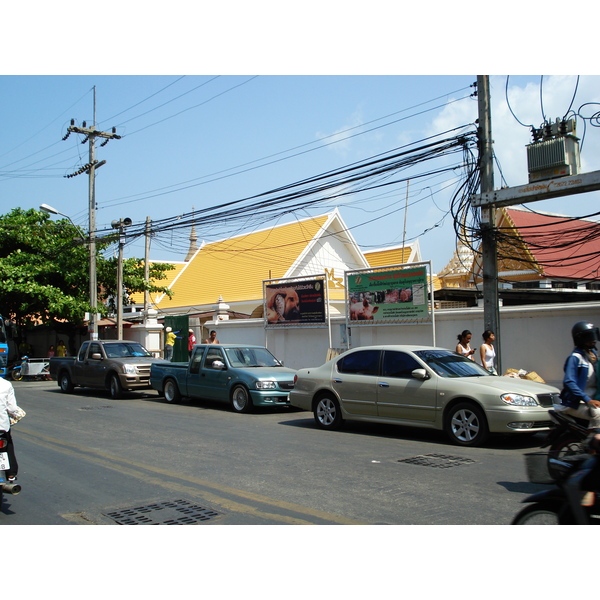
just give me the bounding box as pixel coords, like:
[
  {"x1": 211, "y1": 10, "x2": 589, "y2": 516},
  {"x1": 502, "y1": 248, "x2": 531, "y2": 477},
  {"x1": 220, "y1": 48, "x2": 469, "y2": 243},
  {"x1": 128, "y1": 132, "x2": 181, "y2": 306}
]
[{"x1": 50, "y1": 340, "x2": 165, "y2": 398}]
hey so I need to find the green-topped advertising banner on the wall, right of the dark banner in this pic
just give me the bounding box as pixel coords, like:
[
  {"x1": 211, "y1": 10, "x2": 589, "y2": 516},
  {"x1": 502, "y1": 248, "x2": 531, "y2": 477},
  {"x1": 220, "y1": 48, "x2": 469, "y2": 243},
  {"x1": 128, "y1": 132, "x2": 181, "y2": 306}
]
[{"x1": 347, "y1": 267, "x2": 430, "y2": 325}]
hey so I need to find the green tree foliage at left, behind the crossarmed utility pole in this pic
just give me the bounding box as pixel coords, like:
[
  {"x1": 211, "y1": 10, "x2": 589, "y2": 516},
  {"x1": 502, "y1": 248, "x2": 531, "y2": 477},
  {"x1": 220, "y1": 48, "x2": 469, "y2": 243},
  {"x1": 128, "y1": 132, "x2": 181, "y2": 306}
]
[{"x1": 0, "y1": 208, "x2": 174, "y2": 324}]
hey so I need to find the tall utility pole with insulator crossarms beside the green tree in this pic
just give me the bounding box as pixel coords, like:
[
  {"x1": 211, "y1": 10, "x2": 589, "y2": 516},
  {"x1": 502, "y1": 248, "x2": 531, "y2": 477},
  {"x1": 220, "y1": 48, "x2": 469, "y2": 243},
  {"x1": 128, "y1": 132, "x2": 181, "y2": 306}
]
[{"x1": 63, "y1": 86, "x2": 121, "y2": 340}]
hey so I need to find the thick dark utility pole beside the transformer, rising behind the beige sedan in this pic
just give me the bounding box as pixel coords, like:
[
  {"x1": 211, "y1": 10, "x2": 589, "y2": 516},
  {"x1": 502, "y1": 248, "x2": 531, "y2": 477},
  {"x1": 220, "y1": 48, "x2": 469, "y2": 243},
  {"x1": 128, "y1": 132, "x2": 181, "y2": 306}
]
[{"x1": 477, "y1": 75, "x2": 502, "y2": 373}]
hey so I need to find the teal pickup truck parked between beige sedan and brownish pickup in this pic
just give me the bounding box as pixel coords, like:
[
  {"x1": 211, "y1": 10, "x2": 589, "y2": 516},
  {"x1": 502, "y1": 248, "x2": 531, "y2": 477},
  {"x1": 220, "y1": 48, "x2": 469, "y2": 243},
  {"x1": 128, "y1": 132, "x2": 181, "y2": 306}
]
[{"x1": 150, "y1": 344, "x2": 295, "y2": 412}]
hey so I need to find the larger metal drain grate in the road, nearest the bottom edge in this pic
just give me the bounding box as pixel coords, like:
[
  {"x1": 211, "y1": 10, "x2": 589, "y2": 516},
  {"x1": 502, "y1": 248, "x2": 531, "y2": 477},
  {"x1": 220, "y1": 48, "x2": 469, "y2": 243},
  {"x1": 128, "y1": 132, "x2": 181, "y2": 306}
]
[{"x1": 104, "y1": 500, "x2": 219, "y2": 525}]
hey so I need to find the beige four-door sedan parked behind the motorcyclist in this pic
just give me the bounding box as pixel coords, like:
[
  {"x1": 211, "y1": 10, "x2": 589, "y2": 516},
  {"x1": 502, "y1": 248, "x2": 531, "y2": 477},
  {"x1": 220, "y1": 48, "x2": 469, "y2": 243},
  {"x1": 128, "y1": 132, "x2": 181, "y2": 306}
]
[{"x1": 290, "y1": 346, "x2": 559, "y2": 446}]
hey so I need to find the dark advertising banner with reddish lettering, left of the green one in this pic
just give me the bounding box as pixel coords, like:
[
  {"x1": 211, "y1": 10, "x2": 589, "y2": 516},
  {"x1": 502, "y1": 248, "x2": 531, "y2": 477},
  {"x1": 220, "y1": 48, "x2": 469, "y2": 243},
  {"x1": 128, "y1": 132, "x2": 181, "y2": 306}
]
[{"x1": 264, "y1": 279, "x2": 326, "y2": 327}]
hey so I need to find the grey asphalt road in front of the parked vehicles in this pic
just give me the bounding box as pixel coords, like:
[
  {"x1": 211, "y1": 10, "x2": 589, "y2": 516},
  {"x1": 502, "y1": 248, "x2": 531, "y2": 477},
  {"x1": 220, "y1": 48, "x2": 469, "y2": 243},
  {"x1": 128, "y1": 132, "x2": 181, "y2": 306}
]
[{"x1": 0, "y1": 381, "x2": 542, "y2": 525}]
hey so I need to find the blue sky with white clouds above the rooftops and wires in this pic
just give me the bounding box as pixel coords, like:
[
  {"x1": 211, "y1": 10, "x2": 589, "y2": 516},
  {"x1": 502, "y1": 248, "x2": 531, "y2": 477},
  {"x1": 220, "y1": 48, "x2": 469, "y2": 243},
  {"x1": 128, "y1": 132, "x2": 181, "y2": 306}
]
[{"x1": 0, "y1": 74, "x2": 600, "y2": 271}]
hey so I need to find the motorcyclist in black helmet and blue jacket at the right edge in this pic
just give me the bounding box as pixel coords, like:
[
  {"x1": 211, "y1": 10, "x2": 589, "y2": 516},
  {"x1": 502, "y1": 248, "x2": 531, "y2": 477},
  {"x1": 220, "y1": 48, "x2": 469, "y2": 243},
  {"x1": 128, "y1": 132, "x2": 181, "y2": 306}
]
[{"x1": 555, "y1": 321, "x2": 600, "y2": 428}]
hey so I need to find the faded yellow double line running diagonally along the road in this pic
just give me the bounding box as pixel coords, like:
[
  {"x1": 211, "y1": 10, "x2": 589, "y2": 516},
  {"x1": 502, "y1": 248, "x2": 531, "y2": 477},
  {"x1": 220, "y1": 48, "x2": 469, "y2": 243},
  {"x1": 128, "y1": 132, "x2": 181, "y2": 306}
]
[{"x1": 18, "y1": 426, "x2": 367, "y2": 525}]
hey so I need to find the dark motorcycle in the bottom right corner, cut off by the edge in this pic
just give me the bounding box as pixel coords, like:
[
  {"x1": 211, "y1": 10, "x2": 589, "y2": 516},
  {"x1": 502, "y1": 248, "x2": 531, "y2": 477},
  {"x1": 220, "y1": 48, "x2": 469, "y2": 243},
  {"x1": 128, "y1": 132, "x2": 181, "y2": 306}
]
[{"x1": 512, "y1": 429, "x2": 600, "y2": 525}]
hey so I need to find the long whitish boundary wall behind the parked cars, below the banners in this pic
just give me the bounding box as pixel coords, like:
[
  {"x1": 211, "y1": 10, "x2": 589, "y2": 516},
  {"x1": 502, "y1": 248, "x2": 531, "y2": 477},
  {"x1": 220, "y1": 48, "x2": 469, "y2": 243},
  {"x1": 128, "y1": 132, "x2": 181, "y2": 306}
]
[{"x1": 205, "y1": 302, "x2": 600, "y2": 387}]
